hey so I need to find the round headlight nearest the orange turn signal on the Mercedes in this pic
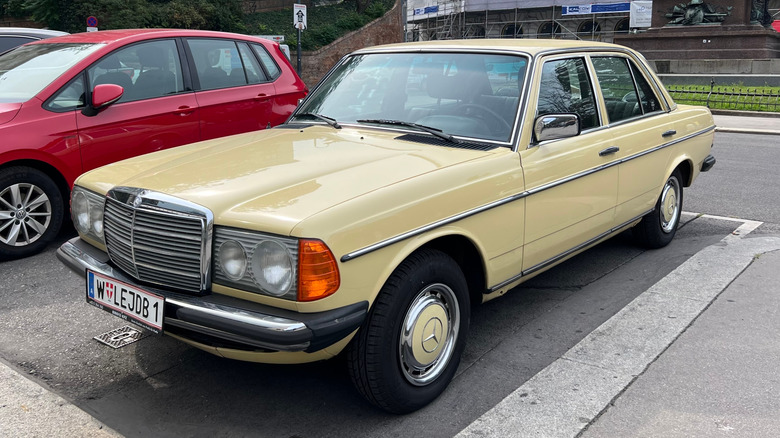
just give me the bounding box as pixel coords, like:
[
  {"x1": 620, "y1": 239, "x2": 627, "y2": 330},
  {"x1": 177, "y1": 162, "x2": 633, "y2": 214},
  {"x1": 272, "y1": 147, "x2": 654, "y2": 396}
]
[{"x1": 252, "y1": 240, "x2": 293, "y2": 297}]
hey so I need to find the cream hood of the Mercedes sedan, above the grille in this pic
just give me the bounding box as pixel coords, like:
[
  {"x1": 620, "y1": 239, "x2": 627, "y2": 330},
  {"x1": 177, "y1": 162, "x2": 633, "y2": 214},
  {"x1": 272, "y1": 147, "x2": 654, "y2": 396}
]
[{"x1": 77, "y1": 126, "x2": 500, "y2": 235}]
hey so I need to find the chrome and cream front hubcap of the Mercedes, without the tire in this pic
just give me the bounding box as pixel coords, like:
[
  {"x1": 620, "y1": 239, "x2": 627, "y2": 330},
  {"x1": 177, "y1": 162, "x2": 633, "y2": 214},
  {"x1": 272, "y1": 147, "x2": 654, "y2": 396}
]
[{"x1": 399, "y1": 283, "x2": 460, "y2": 386}]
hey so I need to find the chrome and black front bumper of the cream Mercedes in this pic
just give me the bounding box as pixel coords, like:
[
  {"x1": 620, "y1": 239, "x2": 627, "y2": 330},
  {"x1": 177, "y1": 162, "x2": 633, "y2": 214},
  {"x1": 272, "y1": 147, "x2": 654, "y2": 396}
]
[{"x1": 57, "y1": 237, "x2": 368, "y2": 353}]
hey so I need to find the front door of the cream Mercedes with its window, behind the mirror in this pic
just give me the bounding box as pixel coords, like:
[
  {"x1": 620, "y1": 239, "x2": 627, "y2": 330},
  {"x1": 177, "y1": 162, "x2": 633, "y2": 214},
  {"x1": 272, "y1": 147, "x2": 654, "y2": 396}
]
[{"x1": 520, "y1": 57, "x2": 618, "y2": 273}]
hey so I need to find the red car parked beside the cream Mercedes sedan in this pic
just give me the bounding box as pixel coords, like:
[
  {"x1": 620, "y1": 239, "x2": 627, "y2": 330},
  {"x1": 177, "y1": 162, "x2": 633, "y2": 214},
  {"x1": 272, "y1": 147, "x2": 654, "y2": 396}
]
[{"x1": 0, "y1": 29, "x2": 308, "y2": 260}]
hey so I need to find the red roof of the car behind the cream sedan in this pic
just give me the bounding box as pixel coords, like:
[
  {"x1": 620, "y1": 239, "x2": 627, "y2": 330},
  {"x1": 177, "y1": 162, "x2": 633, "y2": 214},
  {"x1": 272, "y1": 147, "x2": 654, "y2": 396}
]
[{"x1": 29, "y1": 29, "x2": 268, "y2": 44}]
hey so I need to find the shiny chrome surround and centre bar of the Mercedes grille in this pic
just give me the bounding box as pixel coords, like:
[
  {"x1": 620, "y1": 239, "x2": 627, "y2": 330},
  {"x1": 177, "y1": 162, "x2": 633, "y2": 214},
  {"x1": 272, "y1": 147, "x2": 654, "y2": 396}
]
[{"x1": 106, "y1": 186, "x2": 214, "y2": 291}]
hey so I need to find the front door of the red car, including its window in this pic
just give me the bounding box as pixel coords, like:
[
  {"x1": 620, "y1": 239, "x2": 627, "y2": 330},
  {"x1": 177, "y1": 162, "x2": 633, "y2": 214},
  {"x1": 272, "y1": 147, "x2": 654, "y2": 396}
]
[{"x1": 76, "y1": 39, "x2": 200, "y2": 171}]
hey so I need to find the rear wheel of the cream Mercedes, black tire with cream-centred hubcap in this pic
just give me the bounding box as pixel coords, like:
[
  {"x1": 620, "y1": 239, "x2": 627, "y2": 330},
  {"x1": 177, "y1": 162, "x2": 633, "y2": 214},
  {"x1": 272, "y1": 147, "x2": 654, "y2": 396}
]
[{"x1": 633, "y1": 170, "x2": 683, "y2": 249}]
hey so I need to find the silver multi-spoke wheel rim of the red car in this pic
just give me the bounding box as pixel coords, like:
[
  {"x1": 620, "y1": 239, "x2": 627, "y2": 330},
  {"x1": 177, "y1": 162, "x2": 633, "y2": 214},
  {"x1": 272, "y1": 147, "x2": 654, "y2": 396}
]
[{"x1": 0, "y1": 183, "x2": 51, "y2": 246}]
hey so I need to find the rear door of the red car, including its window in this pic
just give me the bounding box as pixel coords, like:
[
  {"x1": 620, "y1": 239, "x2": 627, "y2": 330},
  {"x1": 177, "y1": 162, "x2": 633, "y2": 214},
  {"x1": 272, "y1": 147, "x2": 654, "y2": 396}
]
[{"x1": 187, "y1": 38, "x2": 278, "y2": 140}]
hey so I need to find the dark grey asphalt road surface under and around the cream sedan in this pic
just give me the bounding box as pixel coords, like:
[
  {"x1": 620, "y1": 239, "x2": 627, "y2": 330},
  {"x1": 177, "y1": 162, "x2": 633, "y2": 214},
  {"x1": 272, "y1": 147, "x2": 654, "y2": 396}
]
[{"x1": 0, "y1": 133, "x2": 780, "y2": 437}]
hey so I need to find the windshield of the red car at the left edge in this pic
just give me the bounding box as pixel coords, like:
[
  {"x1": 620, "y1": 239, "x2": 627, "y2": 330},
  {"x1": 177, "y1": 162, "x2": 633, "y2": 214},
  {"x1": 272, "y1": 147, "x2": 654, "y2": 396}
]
[{"x1": 0, "y1": 44, "x2": 102, "y2": 103}]
